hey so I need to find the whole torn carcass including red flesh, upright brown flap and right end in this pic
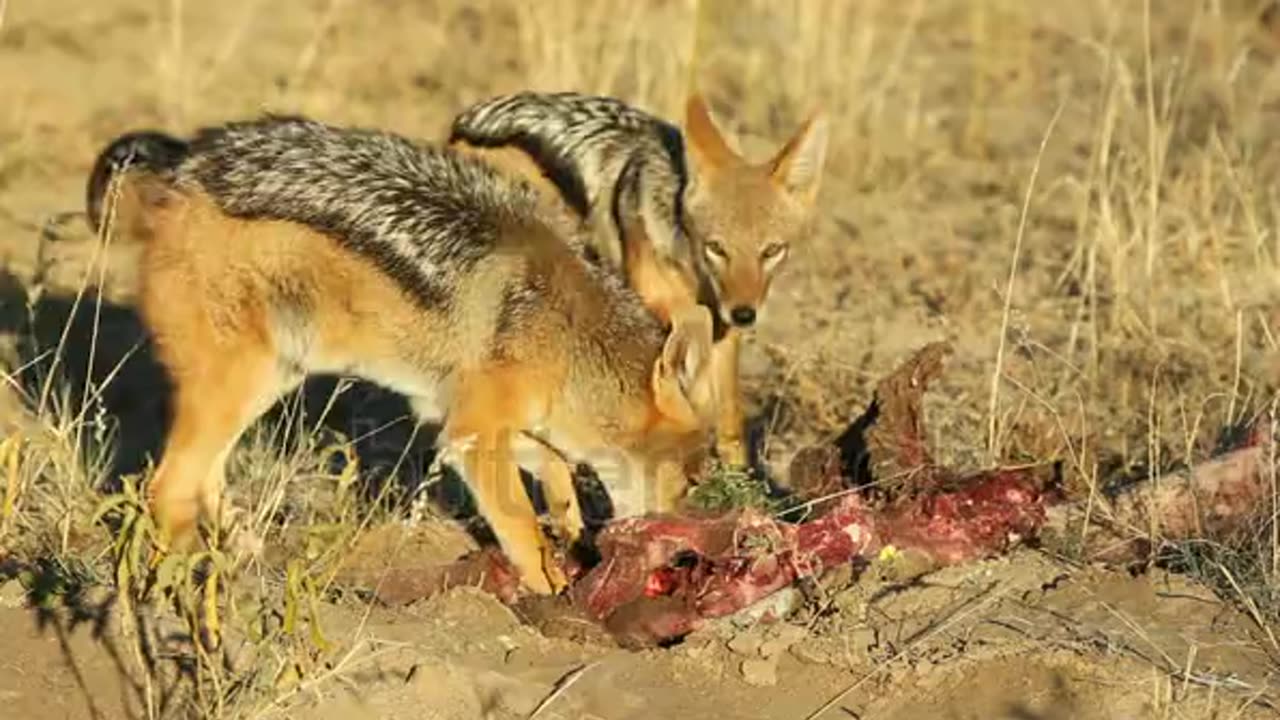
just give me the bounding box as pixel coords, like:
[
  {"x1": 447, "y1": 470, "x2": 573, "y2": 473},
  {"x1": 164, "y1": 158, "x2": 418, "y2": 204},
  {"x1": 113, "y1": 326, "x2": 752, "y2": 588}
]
[{"x1": 373, "y1": 343, "x2": 1268, "y2": 647}]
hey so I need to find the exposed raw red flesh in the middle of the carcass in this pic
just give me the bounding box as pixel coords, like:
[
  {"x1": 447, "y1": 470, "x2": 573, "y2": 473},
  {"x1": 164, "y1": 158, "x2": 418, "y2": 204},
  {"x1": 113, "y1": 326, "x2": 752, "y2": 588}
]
[{"x1": 570, "y1": 461, "x2": 1050, "y2": 646}]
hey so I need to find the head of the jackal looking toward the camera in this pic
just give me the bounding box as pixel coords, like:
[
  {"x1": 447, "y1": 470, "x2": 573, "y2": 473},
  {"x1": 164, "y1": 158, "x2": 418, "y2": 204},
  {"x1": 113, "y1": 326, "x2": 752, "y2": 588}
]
[{"x1": 685, "y1": 95, "x2": 827, "y2": 328}]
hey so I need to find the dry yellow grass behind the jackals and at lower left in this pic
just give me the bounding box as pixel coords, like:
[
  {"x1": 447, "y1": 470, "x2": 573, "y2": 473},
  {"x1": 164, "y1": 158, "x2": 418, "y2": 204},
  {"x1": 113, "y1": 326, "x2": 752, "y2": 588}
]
[{"x1": 0, "y1": 0, "x2": 1280, "y2": 716}]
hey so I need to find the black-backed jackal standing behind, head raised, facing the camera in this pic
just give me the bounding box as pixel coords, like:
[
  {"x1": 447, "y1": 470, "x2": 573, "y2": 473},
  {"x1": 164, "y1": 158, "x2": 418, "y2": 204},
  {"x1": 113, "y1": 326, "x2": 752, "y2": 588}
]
[{"x1": 449, "y1": 92, "x2": 827, "y2": 465}]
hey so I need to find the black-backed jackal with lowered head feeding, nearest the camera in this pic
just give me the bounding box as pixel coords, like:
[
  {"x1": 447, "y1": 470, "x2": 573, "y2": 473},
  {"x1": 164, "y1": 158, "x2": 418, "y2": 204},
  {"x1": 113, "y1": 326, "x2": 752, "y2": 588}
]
[{"x1": 87, "y1": 117, "x2": 716, "y2": 592}]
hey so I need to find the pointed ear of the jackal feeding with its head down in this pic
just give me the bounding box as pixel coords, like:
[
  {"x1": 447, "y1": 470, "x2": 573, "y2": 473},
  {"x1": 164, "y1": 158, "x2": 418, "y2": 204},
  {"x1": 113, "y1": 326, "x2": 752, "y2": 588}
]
[{"x1": 653, "y1": 305, "x2": 716, "y2": 427}]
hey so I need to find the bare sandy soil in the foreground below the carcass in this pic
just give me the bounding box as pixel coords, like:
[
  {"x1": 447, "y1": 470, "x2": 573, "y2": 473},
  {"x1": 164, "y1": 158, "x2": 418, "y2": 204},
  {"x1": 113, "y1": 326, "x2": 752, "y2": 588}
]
[{"x1": 0, "y1": 530, "x2": 1275, "y2": 720}]
